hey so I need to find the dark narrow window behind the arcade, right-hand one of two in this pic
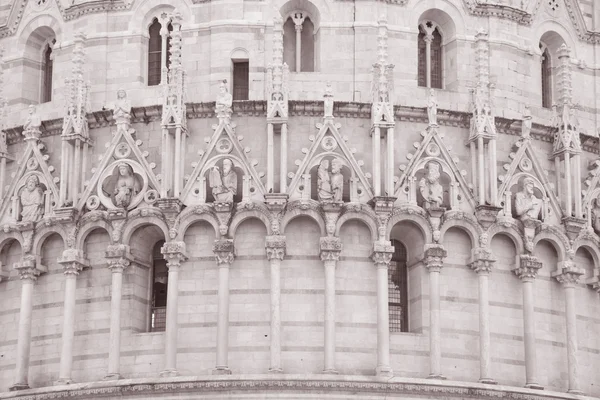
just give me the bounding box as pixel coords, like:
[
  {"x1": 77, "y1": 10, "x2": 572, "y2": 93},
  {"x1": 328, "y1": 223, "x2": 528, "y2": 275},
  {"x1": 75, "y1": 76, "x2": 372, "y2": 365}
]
[{"x1": 388, "y1": 240, "x2": 408, "y2": 332}]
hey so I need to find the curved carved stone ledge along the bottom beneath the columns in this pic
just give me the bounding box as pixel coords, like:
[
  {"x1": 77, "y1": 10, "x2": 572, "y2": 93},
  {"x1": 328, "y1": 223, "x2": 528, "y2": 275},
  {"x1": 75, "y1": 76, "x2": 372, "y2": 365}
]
[{"x1": 0, "y1": 375, "x2": 592, "y2": 400}]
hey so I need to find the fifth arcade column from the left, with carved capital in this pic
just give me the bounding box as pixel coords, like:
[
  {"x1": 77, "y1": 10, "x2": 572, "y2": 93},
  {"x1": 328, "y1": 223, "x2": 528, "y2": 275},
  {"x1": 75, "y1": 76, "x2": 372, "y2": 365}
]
[{"x1": 213, "y1": 239, "x2": 234, "y2": 375}]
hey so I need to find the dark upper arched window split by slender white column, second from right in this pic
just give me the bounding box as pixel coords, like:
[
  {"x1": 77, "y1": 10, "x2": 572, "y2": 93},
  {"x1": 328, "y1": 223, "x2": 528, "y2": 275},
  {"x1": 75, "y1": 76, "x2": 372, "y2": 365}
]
[{"x1": 417, "y1": 21, "x2": 443, "y2": 89}]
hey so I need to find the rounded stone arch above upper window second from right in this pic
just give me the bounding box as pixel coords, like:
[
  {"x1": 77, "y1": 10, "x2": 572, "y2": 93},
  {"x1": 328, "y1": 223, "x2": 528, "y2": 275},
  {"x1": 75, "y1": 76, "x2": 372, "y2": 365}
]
[{"x1": 410, "y1": 0, "x2": 466, "y2": 38}]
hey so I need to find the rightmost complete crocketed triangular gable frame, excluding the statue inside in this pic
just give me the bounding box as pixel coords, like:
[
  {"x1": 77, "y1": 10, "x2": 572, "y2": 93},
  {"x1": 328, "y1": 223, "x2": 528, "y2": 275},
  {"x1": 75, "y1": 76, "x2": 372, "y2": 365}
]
[{"x1": 497, "y1": 138, "x2": 562, "y2": 224}]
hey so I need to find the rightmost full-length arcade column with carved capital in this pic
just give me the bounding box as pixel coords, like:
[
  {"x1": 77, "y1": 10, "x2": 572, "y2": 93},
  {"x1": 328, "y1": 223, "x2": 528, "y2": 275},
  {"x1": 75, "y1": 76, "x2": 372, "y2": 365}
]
[{"x1": 552, "y1": 261, "x2": 584, "y2": 394}]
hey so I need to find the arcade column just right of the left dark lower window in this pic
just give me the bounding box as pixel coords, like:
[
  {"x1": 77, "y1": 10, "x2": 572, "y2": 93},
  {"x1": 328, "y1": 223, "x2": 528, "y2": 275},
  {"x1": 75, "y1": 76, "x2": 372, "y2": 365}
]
[{"x1": 160, "y1": 242, "x2": 187, "y2": 377}]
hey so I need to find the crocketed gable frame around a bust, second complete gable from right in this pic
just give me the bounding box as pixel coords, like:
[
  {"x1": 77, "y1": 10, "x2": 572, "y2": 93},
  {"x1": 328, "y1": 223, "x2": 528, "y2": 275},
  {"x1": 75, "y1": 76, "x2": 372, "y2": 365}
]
[{"x1": 394, "y1": 125, "x2": 475, "y2": 212}]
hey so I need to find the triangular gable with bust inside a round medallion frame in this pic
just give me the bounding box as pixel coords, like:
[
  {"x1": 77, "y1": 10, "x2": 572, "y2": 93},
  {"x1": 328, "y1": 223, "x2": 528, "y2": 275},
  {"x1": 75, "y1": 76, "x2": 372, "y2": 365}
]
[{"x1": 76, "y1": 128, "x2": 160, "y2": 211}]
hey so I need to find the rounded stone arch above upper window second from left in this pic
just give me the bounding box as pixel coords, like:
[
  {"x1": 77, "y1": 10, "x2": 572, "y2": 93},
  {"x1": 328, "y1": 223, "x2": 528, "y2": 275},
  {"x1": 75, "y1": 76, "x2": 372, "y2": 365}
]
[{"x1": 129, "y1": 0, "x2": 194, "y2": 36}]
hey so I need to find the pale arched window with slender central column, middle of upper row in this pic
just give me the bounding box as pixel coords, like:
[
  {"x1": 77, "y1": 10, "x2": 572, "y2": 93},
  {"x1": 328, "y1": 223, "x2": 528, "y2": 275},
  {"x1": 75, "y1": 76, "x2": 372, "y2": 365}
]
[{"x1": 283, "y1": 11, "x2": 316, "y2": 72}]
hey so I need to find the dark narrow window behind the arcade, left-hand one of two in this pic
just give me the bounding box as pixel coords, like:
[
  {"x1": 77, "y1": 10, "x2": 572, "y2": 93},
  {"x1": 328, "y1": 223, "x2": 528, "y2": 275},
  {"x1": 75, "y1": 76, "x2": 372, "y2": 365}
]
[{"x1": 150, "y1": 240, "x2": 169, "y2": 332}]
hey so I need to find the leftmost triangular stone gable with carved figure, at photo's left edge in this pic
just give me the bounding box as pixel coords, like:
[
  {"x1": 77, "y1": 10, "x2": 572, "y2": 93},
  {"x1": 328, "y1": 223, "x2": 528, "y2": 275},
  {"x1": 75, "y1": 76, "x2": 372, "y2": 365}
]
[{"x1": 0, "y1": 138, "x2": 59, "y2": 224}]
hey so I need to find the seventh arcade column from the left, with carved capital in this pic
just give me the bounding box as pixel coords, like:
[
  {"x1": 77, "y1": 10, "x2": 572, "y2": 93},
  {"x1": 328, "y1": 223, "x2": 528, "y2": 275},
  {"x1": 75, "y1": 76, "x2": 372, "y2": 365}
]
[{"x1": 320, "y1": 236, "x2": 342, "y2": 374}]
